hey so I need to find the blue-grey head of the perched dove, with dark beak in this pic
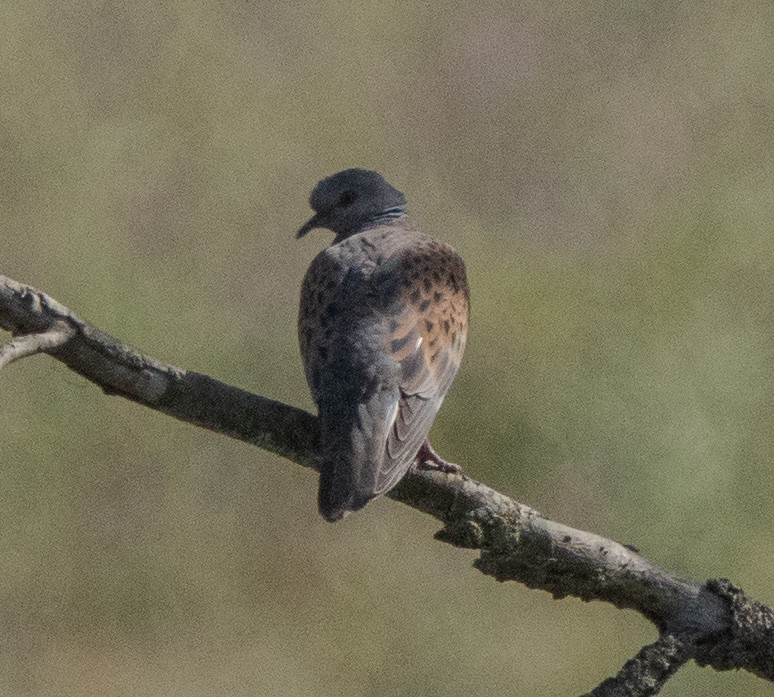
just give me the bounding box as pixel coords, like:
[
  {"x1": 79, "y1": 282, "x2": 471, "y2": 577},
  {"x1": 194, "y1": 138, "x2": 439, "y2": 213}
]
[{"x1": 297, "y1": 169, "x2": 406, "y2": 240}]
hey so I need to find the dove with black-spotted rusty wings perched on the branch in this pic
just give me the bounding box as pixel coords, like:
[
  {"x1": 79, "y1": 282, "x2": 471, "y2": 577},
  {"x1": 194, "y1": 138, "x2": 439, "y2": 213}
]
[{"x1": 296, "y1": 168, "x2": 470, "y2": 522}]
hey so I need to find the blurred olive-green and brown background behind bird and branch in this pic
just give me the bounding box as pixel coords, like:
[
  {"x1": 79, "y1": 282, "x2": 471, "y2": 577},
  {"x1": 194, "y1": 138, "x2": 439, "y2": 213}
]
[{"x1": 0, "y1": 0, "x2": 774, "y2": 697}]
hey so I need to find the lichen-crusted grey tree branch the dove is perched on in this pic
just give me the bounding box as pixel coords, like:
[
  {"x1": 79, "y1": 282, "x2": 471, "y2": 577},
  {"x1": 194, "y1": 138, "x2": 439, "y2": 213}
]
[{"x1": 0, "y1": 276, "x2": 774, "y2": 696}]
